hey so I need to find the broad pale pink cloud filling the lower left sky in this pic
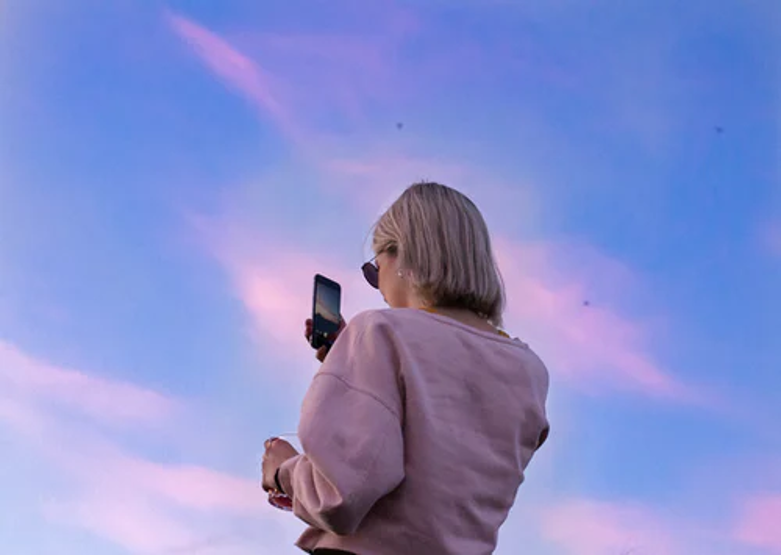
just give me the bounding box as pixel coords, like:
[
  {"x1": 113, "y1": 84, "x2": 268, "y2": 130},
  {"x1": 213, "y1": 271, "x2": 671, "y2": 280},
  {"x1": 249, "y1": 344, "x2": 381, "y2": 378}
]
[{"x1": 0, "y1": 342, "x2": 300, "y2": 553}]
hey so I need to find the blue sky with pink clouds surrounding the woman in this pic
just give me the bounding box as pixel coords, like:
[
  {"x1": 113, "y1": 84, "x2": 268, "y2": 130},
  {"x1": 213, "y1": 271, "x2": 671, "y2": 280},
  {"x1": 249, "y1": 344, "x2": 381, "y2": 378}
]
[{"x1": 0, "y1": 0, "x2": 781, "y2": 554}]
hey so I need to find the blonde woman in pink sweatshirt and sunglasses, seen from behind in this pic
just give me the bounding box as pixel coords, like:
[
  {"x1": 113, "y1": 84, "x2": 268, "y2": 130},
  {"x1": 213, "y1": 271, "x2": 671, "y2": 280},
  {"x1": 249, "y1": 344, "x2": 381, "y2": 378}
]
[{"x1": 263, "y1": 183, "x2": 548, "y2": 554}]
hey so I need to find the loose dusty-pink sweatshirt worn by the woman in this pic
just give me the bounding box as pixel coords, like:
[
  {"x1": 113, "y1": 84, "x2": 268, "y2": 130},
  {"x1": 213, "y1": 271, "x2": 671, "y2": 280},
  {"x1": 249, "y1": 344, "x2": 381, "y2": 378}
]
[{"x1": 279, "y1": 309, "x2": 548, "y2": 555}]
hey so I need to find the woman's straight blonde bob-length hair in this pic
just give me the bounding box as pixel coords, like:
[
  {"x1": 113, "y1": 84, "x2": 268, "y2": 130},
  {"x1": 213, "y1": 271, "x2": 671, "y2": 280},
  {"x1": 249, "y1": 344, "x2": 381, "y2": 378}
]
[{"x1": 372, "y1": 182, "x2": 505, "y2": 327}]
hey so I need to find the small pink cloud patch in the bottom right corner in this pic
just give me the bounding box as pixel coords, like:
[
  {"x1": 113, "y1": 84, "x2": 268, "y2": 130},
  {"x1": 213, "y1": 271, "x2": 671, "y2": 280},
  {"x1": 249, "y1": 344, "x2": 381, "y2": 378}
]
[{"x1": 734, "y1": 492, "x2": 781, "y2": 554}]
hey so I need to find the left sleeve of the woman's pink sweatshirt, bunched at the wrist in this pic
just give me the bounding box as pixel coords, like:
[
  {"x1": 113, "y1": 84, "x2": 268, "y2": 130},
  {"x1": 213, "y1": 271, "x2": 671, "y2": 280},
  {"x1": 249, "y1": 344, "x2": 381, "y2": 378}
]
[{"x1": 279, "y1": 311, "x2": 404, "y2": 535}]
